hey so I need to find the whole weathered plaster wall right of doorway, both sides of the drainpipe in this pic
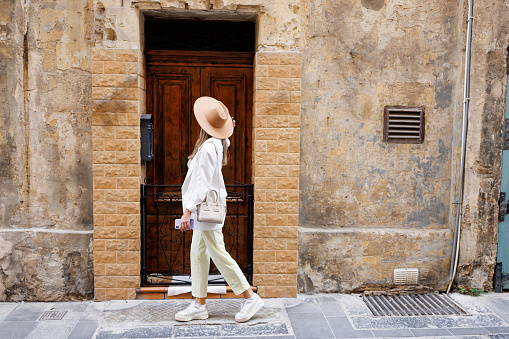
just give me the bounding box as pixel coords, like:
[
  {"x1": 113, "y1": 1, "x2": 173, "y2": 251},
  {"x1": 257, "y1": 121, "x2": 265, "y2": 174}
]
[{"x1": 298, "y1": 0, "x2": 509, "y2": 292}]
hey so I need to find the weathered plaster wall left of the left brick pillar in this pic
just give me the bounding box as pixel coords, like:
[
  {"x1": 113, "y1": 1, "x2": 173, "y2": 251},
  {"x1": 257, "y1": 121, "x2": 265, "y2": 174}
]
[{"x1": 0, "y1": 0, "x2": 93, "y2": 300}]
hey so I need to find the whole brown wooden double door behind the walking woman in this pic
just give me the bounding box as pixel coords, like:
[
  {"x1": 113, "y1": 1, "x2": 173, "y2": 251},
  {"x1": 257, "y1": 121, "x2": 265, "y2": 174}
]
[{"x1": 145, "y1": 51, "x2": 254, "y2": 284}]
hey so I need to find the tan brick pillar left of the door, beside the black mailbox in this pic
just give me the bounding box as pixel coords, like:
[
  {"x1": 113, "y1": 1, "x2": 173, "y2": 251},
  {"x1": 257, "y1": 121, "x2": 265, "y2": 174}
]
[{"x1": 92, "y1": 48, "x2": 145, "y2": 300}]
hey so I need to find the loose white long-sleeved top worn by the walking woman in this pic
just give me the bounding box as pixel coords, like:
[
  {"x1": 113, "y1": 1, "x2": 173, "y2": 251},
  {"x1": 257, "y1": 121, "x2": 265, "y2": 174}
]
[{"x1": 182, "y1": 137, "x2": 230, "y2": 231}]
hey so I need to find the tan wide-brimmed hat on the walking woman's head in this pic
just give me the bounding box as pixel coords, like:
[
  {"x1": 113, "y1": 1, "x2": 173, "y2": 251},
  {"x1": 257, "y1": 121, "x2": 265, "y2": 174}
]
[{"x1": 194, "y1": 97, "x2": 233, "y2": 139}]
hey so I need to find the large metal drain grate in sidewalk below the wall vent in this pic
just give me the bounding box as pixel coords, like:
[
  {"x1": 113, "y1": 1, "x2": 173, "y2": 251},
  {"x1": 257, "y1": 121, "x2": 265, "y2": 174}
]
[{"x1": 362, "y1": 294, "x2": 469, "y2": 317}]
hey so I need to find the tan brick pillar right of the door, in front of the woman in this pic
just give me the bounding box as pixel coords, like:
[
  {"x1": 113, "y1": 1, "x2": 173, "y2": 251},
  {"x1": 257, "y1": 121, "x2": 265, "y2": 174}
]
[{"x1": 253, "y1": 52, "x2": 301, "y2": 298}]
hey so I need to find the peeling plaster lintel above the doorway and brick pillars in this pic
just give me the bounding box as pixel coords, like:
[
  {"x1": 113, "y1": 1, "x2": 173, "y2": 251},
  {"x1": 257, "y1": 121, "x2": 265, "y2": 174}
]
[{"x1": 109, "y1": 0, "x2": 307, "y2": 51}]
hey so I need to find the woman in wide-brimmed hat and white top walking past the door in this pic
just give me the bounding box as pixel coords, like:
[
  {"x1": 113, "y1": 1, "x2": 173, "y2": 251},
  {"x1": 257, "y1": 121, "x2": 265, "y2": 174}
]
[{"x1": 175, "y1": 97, "x2": 263, "y2": 322}]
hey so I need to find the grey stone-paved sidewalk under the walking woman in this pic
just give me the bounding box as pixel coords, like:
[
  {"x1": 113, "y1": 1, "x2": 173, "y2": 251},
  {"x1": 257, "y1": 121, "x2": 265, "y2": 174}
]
[{"x1": 0, "y1": 293, "x2": 509, "y2": 339}]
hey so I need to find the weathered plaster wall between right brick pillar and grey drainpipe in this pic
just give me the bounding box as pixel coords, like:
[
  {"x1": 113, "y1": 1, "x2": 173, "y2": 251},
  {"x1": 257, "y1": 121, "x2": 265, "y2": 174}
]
[{"x1": 299, "y1": 0, "x2": 463, "y2": 292}]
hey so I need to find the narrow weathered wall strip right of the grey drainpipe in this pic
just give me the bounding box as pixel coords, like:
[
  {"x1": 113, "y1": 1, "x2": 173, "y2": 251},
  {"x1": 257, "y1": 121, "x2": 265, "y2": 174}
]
[{"x1": 457, "y1": 1, "x2": 509, "y2": 290}]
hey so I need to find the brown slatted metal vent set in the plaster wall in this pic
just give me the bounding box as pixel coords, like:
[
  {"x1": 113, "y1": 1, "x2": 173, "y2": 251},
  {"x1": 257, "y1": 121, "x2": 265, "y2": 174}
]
[{"x1": 384, "y1": 106, "x2": 424, "y2": 144}]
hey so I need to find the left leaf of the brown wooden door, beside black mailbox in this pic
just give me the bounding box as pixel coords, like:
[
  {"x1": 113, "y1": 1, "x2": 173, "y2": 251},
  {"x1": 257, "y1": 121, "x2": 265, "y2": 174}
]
[{"x1": 145, "y1": 65, "x2": 200, "y2": 275}]
